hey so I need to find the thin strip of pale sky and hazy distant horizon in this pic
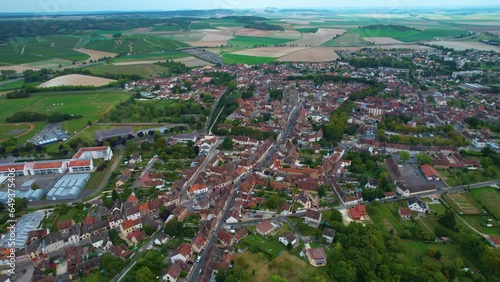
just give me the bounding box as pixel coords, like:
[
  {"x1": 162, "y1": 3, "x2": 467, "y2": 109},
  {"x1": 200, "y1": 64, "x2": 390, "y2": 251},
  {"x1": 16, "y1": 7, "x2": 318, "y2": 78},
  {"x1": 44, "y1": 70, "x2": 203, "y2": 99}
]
[{"x1": 0, "y1": 0, "x2": 500, "y2": 14}]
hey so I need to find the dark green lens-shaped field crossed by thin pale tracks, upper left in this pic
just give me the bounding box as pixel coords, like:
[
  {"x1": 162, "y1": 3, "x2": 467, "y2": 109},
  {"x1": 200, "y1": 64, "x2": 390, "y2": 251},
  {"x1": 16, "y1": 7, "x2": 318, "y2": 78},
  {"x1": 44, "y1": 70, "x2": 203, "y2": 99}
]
[{"x1": 85, "y1": 34, "x2": 188, "y2": 54}]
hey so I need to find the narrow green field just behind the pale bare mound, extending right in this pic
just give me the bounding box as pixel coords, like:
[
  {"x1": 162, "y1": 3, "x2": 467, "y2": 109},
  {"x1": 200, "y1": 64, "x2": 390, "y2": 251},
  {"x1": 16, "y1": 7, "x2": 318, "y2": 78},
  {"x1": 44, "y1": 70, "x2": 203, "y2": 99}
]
[{"x1": 85, "y1": 64, "x2": 169, "y2": 77}]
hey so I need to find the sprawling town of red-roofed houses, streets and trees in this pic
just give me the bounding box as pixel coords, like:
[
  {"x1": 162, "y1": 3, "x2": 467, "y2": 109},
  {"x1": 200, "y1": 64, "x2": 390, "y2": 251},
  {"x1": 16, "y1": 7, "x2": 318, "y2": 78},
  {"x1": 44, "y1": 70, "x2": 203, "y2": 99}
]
[{"x1": 0, "y1": 23, "x2": 500, "y2": 281}]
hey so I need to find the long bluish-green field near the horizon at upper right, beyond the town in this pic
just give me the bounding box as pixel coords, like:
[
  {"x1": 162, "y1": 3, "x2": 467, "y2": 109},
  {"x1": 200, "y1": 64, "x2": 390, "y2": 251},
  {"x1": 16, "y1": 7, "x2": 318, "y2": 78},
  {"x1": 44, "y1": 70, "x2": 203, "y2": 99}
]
[{"x1": 354, "y1": 28, "x2": 467, "y2": 42}]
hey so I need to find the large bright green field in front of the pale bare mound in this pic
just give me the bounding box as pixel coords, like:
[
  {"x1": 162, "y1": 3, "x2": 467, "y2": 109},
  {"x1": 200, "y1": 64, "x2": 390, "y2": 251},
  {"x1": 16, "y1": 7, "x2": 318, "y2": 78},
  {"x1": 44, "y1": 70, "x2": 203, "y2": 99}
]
[{"x1": 0, "y1": 89, "x2": 130, "y2": 134}]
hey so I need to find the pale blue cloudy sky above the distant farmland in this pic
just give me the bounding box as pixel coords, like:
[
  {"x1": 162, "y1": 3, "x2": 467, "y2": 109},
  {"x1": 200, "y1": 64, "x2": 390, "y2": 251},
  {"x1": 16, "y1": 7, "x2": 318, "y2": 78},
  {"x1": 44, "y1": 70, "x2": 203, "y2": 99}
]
[{"x1": 0, "y1": 0, "x2": 500, "y2": 13}]
